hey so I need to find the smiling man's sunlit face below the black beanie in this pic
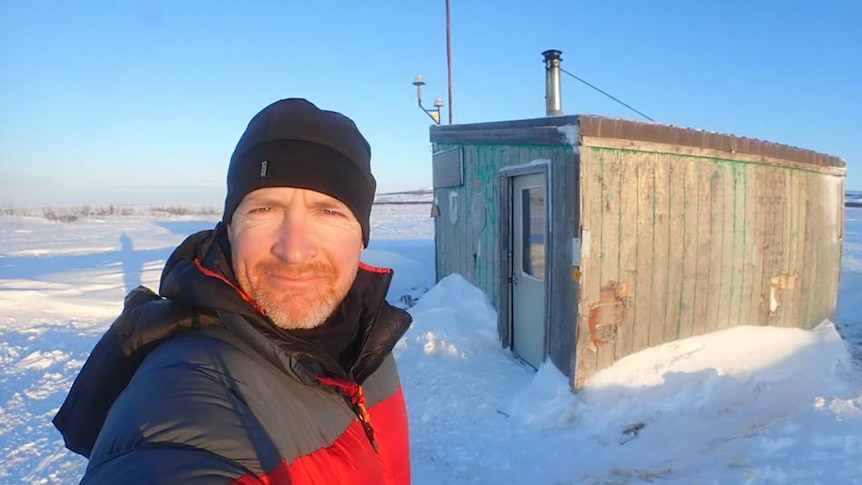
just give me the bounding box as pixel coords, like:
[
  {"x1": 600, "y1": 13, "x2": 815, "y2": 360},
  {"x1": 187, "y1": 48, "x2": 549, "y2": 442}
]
[{"x1": 228, "y1": 187, "x2": 363, "y2": 328}]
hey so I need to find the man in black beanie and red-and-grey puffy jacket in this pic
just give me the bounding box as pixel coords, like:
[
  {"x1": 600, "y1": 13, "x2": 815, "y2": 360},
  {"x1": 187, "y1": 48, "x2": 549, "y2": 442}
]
[{"x1": 54, "y1": 99, "x2": 410, "y2": 485}]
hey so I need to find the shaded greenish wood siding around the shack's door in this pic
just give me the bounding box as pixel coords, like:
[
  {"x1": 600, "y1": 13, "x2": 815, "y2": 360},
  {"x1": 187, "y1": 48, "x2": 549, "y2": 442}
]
[{"x1": 432, "y1": 140, "x2": 579, "y2": 375}]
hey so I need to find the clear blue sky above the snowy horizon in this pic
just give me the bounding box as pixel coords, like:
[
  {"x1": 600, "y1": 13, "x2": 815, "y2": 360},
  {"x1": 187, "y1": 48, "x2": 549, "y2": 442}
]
[{"x1": 0, "y1": 0, "x2": 862, "y2": 207}]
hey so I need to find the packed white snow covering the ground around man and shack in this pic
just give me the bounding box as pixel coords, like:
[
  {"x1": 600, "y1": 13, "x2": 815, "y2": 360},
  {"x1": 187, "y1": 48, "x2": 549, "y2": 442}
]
[{"x1": 0, "y1": 205, "x2": 862, "y2": 485}]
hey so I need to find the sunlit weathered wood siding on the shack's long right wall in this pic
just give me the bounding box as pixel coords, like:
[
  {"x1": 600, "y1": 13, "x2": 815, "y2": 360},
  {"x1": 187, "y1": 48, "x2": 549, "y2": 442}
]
[{"x1": 573, "y1": 137, "x2": 844, "y2": 387}]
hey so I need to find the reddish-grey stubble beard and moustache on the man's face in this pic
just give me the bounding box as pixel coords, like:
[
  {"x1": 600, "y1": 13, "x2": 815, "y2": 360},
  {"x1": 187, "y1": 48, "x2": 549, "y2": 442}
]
[{"x1": 249, "y1": 267, "x2": 340, "y2": 330}]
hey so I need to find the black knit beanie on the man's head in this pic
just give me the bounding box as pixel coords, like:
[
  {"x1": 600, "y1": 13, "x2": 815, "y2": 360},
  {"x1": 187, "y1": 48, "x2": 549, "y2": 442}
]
[{"x1": 222, "y1": 98, "x2": 377, "y2": 247}]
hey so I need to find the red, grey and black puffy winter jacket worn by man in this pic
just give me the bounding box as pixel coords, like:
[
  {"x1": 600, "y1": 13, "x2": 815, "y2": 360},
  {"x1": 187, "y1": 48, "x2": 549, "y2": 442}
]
[{"x1": 54, "y1": 225, "x2": 410, "y2": 485}]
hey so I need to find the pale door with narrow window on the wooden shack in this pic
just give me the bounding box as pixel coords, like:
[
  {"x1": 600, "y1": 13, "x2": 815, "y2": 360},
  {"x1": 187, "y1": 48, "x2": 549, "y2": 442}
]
[{"x1": 509, "y1": 173, "x2": 548, "y2": 369}]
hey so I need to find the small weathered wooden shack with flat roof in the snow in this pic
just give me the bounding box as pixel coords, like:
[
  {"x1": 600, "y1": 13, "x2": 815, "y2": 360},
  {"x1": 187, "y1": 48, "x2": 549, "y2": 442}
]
[{"x1": 430, "y1": 115, "x2": 845, "y2": 389}]
